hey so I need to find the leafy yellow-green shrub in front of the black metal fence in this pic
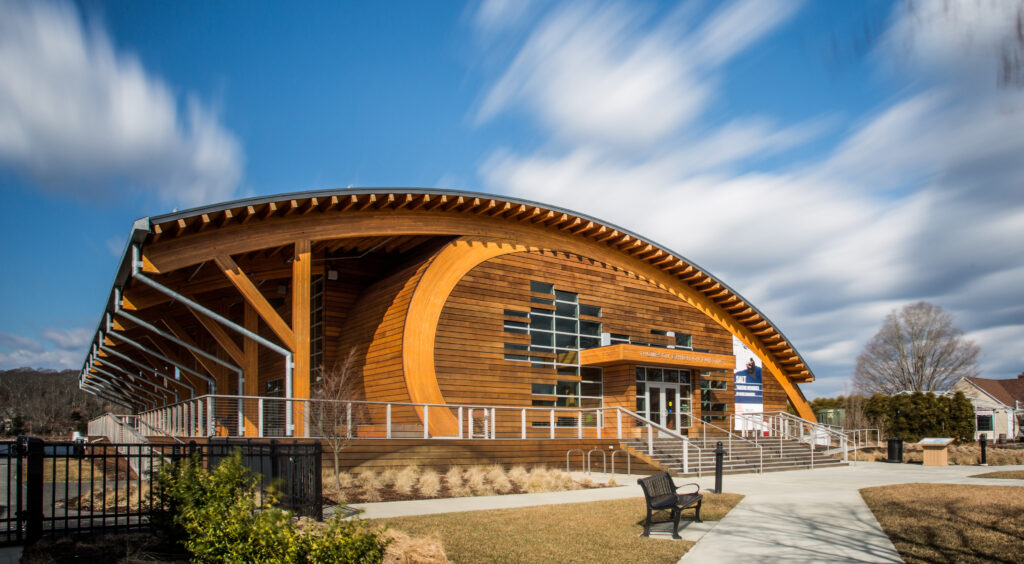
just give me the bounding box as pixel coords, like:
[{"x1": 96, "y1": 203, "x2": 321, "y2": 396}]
[{"x1": 154, "y1": 451, "x2": 387, "y2": 563}]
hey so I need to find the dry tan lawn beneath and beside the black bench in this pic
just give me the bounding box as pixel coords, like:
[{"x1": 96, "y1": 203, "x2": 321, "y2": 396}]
[{"x1": 373, "y1": 493, "x2": 743, "y2": 564}]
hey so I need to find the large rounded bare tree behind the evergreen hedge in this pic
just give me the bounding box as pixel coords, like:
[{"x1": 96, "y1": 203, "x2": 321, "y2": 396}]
[{"x1": 853, "y1": 302, "x2": 980, "y2": 394}]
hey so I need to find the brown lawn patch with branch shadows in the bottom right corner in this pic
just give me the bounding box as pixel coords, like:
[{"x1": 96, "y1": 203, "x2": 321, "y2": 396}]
[{"x1": 860, "y1": 484, "x2": 1024, "y2": 563}]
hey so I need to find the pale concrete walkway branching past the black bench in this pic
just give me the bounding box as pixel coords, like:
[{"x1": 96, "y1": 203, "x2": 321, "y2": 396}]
[{"x1": 339, "y1": 462, "x2": 1024, "y2": 564}]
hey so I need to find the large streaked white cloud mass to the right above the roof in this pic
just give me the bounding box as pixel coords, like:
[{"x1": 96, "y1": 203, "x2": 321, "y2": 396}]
[{"x1": 479, "y1": 1, "x2": 1024, "y2": 397}]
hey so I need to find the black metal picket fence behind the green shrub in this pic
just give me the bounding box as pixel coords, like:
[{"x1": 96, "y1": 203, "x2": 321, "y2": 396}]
[{"x1": 0, "y1": 438, "x2": 323, "y2": 545}]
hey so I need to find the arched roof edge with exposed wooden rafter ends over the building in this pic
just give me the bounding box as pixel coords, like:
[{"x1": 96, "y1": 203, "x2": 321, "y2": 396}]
[{"x1": 86, "y1": 188, "x2": 814, "y2": 415}]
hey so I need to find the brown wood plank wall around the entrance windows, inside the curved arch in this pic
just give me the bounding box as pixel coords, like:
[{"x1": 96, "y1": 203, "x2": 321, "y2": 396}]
[{"x1": 434, "y1": 252, "x2": 732, "y2": 410}]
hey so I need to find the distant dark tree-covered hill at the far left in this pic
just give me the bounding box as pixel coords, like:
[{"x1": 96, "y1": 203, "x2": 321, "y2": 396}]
[{"x1": 0, "y1": 368, "x2": 116, "y2": 438}]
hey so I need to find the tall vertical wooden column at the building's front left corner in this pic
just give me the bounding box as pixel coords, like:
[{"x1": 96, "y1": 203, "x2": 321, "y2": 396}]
[{"x1": 292, "y1": 238, "x2": 312, "y2": 437}]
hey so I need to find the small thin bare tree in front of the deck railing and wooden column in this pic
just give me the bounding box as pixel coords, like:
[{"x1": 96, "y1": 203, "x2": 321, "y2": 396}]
[{"x1": 309, "y1": 347, "x2": 367, "y2": 489}]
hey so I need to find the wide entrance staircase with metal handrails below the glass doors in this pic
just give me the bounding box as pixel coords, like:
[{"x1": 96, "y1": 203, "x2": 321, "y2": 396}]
[{"x1": 621, "y1": 435, "x2": 847, "y2": 476}]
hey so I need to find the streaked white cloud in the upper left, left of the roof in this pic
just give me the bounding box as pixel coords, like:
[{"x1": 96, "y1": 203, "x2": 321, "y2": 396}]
[{"x1": 0, "y1": 1, "x2": 243, "y2": 206}]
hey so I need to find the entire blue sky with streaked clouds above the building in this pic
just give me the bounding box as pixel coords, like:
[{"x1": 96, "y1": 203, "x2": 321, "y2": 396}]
[{"x1": 0, "y1": 0, "x2": 1024, "y2": 397}]
